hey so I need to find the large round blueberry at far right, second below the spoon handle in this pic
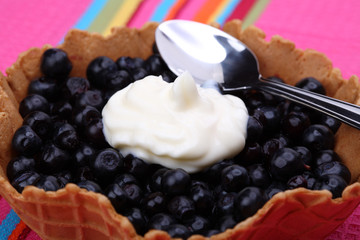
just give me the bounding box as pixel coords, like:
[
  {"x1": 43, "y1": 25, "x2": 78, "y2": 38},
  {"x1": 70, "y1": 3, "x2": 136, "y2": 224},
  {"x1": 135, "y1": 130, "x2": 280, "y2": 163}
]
[{"x1": 302, "y1": 124, "x2": 335, "y2": 152}]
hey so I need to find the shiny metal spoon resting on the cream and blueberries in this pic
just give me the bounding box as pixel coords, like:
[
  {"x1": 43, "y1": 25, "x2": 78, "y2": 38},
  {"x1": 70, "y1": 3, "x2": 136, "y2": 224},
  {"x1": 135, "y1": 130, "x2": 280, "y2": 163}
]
[{"x1": 155, "y1": 20, "x2": 360, "y2": 129}]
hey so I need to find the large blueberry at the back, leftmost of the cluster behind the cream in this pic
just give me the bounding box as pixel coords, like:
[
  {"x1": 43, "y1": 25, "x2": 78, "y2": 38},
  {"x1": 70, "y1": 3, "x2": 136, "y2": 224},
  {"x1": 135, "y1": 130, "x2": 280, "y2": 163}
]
[{"x1": 86, "y1": 56, "x2": 118, "y2": 89}]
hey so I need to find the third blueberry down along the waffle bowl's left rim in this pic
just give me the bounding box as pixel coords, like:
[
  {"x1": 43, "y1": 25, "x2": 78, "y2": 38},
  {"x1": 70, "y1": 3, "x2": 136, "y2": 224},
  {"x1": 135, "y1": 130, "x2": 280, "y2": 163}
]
[{"x1": 19, "y1": 94, "x2": 50, "y2": 117}]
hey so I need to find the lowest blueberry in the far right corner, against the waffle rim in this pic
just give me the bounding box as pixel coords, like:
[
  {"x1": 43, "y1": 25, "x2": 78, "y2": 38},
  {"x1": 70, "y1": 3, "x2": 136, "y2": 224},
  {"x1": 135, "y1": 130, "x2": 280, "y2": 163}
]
[{"x1": 314, "y1": 175, "x2": 347, "y2": 198}]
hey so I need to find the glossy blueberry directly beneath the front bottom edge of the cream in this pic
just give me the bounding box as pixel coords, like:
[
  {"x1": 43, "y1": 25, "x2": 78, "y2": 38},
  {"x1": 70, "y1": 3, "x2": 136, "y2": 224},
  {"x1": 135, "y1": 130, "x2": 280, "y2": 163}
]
[{"x1": 161, "y1": 168, "x2": 191, "y2": 195}]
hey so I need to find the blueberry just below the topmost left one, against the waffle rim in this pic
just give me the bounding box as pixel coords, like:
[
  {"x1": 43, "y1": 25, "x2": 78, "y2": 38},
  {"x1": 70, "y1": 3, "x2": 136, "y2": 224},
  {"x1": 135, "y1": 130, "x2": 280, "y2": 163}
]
[{"x1": 28, "y1": 77, "x2": 60, "y2": 101}]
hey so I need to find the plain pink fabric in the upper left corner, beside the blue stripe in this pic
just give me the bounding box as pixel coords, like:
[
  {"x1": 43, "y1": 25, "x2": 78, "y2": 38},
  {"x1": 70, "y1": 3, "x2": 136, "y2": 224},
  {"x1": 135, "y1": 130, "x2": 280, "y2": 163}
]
[{"x1": 0, "y1": 0, "x2": 91, "y2": 73}]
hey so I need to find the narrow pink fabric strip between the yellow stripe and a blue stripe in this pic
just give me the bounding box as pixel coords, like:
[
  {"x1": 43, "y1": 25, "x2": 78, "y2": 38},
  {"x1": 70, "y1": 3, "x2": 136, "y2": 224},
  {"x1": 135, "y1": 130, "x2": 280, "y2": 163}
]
[{"x1": 128, "y1": 0, "x2": 161, "y2": 28}]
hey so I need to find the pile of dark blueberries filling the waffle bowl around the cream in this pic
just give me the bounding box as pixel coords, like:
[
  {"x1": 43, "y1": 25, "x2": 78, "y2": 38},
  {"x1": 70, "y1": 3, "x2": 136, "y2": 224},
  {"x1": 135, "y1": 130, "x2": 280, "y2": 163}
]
[{"x1": 7, "y1": 48, "x2": 351, "y2": 238}]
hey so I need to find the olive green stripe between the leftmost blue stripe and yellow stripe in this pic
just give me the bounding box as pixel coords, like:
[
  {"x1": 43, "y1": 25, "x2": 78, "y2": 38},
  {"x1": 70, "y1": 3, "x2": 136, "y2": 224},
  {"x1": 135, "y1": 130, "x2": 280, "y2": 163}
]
[{"x1": 87, "y1": 0, "x2": 124, "y2": 33}]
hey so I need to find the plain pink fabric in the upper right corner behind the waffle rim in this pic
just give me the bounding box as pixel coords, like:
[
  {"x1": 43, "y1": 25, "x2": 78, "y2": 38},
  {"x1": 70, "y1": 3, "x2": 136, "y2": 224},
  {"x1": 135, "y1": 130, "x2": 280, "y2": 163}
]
[{"x1": 256, "y1": 0, "x2": 360, "y2": 78}]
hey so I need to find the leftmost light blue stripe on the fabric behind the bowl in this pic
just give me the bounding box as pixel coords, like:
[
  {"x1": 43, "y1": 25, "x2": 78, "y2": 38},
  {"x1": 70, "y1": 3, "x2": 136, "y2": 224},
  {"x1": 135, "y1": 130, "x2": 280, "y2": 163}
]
[{"x1": 74, "y1": 0, "x2": 108, "y2": 30}]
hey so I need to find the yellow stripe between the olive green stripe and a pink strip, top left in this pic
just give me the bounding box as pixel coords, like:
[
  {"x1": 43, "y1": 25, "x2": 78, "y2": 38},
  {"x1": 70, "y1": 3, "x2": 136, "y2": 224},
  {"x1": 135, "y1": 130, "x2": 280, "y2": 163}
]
[{"x1": 103, "y1": 0, "x2": 142, "y2": 36}]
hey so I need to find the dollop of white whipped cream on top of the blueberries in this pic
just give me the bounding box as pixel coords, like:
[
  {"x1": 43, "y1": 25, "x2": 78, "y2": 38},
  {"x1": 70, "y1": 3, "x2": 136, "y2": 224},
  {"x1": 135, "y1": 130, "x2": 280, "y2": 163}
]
[{"x1": 102, "y1": 72, "x2": 248, "y2": 173}]
